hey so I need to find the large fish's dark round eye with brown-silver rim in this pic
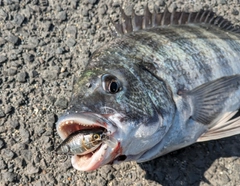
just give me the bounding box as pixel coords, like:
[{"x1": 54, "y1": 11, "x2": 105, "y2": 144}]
[{"x1": 102, "y1": 74, "x2": 122, "y2": 94}]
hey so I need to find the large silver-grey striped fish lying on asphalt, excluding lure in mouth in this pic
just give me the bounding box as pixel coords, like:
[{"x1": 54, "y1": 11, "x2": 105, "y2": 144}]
[{"x1": 56, "y1": 7, "x2": 240, "y2": 171}]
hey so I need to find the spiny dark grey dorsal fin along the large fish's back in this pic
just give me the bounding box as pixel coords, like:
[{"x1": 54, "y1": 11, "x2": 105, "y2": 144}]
[{"x1": 114, "y1": 6, "x2": 240, "y2": 34}]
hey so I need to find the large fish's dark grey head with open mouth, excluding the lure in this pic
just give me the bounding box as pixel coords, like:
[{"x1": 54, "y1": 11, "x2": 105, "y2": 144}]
[{"x1": 56, "y1": 65, "x2": 169, "y2": 171}]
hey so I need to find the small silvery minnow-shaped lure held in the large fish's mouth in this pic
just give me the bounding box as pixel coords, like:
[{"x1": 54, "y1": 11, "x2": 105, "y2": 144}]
[{"x1": 56, "y1": 129, "x2": 108, "y2": 155}]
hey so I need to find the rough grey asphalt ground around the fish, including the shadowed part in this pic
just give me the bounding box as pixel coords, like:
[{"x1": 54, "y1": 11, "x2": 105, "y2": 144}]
[{"x1": 0, "y1": 0, "x2": 240, "y2": 186}]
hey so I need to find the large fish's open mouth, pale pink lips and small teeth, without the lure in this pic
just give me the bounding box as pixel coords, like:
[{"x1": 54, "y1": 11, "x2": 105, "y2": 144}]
[{"x1": 56, "y1": 113, "x2": 120, "y2": 171}]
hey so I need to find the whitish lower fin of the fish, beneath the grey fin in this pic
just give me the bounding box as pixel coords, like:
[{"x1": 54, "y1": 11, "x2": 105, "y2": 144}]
[{"x1": 197, "y1": 111, "x2": 240, "y2": 142}]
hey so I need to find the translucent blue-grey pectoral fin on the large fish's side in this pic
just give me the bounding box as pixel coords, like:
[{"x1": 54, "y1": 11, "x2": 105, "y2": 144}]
[{"x1": 178, "y1": 75, "x2": 240, "y2": 126}]
